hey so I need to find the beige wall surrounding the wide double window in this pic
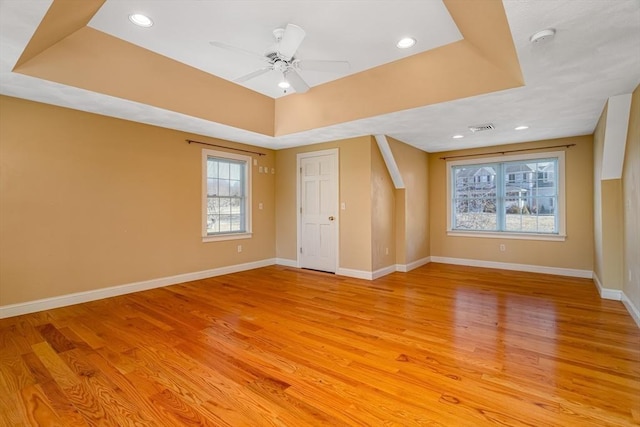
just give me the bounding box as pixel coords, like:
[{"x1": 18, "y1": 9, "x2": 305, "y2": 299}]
[{"x1": 429, "y1": 136, "x2": 593, "y2": 271}]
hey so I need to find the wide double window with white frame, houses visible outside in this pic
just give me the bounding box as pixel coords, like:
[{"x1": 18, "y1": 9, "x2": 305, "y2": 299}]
[{"x1": 447, "y1": 152, "x2": 565, "y2": 240}]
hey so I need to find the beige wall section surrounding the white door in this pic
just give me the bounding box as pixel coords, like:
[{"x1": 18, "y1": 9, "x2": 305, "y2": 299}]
[{"x1": 275, "y1": 136, "x2": 373, "y2": 271}]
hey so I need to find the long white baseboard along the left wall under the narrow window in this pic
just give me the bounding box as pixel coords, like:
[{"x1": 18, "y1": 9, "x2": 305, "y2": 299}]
[{"x1": 0, "y1": 258, "x2": 275, "y2": 319}]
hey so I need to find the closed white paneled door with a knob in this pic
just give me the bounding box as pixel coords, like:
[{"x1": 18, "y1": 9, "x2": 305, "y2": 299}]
[{"x1": 298, "y1": 150, "x2": 338, "y2": 273}]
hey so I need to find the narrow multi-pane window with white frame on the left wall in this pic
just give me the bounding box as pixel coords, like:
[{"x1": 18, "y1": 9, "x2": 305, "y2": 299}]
[{"x1": 202, "y1": 150, "x2": 251, "y2": 241}]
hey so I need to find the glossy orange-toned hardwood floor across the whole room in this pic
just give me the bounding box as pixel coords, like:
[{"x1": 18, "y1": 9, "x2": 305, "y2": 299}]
[{"x1": 0, "y1": 264, "x2": 640, "y2": 426}]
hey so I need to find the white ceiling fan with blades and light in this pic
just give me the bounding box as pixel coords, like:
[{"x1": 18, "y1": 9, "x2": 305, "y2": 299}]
[{"x1": 210, "y1": 24, "x2": 349, "y2": 93}]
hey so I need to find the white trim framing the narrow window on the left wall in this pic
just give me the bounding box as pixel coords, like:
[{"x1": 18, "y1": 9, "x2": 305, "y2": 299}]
[{"x1": 200, "y1": 148, "x2": 253, "y2": 243}]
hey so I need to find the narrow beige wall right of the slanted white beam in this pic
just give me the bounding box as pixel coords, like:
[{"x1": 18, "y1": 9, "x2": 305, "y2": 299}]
[{"x1": 387, "y1": 137, "x2": 430, "y2": 265}]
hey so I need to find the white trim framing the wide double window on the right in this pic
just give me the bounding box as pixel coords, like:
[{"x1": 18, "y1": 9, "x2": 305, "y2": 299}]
[{"x1": 446, "y1": 151, "x2": 567, "y2": 241}]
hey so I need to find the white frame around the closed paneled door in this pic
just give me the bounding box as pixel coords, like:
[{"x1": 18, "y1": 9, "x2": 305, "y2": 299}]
[{"x1": 296, "y1": 148, "x2": 340, "y2": 273}]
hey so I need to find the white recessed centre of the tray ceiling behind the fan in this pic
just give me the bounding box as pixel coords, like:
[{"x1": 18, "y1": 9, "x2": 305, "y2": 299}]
[{"x1": 89, "y1": 0, "x2": 462, "y2": 98}]
